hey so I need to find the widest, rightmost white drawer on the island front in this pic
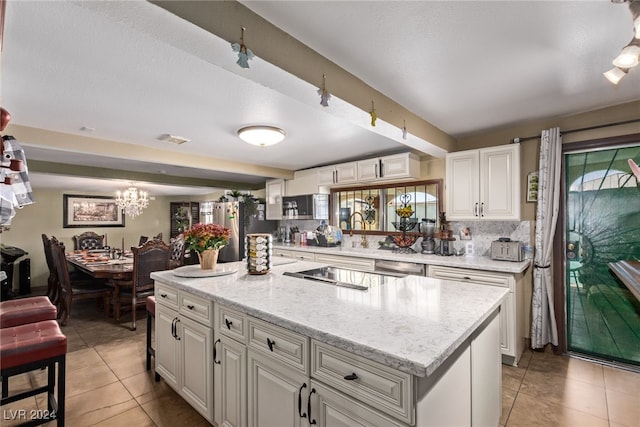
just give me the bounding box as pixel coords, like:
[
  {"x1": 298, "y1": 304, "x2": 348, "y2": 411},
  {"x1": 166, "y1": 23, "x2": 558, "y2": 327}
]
[{"x1": 311, "y1": 340, "x2": 415, "y2": 424}]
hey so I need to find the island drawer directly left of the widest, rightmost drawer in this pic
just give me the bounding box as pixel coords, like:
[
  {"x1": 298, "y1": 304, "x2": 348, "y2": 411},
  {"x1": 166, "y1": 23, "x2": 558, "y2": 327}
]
[{"x1": 248, "y1": 317, "x2": 309, "y2": 375}]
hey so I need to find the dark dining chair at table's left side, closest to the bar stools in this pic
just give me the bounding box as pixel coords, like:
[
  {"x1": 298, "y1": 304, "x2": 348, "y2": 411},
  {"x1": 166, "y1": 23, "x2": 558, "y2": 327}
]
[{"x1": 51, "y1": 237, "x2": 112, "y2": 326}]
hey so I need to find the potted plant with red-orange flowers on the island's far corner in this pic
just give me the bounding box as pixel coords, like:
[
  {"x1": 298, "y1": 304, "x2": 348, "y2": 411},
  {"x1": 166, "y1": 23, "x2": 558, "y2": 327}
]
[{"x1": 184, "y1": 223, "x2": 231, "y2": 270}]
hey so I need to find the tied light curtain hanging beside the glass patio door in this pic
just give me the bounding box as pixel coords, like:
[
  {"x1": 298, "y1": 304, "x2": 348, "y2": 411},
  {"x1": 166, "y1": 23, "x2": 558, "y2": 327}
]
[{"x1": 531, "y1": 128, "x2": 562, "y2": 348}]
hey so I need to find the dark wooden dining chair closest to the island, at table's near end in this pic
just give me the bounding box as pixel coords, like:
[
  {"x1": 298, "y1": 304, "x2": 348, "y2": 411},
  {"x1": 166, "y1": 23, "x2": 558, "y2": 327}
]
[{"x1": 113, "y1": 239, "x2": 169, "y2": 331}]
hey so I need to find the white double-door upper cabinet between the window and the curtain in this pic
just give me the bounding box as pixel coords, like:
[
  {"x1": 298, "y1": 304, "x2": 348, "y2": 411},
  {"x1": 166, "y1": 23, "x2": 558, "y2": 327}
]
[{"x1": 445, "y1": 144, "x2": 520, "y2": 220}]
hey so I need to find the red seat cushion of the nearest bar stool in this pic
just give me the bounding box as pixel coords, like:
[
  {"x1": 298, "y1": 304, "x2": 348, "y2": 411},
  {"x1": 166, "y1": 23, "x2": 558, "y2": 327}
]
[{"x1": 0, "y1": 320, "x2": 67, "y2": 369}]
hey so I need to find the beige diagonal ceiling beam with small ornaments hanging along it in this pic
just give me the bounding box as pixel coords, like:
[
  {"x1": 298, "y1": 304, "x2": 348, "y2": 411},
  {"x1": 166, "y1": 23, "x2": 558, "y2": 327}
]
[{"x1": 150, "y1": 0, "x2": 456, "y2": 155}]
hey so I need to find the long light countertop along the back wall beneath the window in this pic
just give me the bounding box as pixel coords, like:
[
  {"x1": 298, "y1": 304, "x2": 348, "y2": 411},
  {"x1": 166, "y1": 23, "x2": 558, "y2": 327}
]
[{"x1": 273, "y1": 243, "x2": 531, "y2": 273}]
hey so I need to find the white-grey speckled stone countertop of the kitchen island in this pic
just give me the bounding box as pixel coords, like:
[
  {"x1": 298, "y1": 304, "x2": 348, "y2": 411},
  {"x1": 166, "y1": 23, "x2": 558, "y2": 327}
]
[{"x1": 151, "y1": 260, "x2": 508, "y2": 377}]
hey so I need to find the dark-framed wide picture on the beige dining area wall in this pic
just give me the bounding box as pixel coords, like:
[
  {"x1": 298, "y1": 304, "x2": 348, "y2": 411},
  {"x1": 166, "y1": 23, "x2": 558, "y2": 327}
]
[{"x1": 62, "y1": 194, "x2": 124, "y2": 228}]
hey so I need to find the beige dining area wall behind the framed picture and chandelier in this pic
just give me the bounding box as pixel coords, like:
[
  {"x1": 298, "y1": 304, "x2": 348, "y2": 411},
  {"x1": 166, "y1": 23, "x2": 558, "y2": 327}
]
[{"x1": 0, "y1": 189, "x2": 235, "y2": 288}]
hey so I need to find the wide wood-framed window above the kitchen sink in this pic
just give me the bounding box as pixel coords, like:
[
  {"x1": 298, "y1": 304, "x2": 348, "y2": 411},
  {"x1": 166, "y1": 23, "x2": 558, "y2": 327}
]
[{"x1": 331, "y1": 179, "x2": 443, "y2": 234}]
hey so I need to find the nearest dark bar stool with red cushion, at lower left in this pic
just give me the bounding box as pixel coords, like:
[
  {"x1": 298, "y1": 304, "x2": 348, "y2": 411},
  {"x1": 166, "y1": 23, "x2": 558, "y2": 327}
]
[{"x1": 0, "y1": 320, "x2": 67, "y2": 426}]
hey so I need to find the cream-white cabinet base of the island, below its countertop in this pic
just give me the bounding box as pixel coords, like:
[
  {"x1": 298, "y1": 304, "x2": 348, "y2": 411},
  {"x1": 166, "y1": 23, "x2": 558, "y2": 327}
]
[{"x1": 156, "y1": 290, "x2": 501, "y2": 427}]
